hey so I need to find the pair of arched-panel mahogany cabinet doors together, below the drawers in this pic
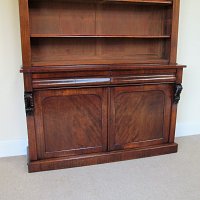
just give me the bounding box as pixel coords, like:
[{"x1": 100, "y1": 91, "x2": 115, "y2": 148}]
[{"x1": 34, "y1": 84, "x2": 174, "y2": 159}]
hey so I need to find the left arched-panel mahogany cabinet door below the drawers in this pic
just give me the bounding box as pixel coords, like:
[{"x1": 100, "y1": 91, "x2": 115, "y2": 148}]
[{"x1": 34, "y1": 88, "x2": 108, "y2": 159}]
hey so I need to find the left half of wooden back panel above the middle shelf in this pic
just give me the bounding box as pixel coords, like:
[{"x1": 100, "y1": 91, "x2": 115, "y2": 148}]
[{"x1": 30, "y1": 1, "x2": 95, "y2": 35}]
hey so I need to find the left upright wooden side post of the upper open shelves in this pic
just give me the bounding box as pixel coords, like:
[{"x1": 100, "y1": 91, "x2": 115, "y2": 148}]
[{"x1": 19, "y1": 0, "x2": 31, "y2": 67}]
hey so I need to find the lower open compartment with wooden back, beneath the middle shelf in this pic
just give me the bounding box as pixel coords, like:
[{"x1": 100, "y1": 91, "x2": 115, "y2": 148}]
[{"x1": 32, "y1": 38, "x2": 169, "y2": 66}]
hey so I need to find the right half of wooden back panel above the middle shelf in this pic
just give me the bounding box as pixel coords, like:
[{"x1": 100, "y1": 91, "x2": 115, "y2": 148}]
[{"x1": 96, "y1": 4, "x2": 170, "y2": 35}]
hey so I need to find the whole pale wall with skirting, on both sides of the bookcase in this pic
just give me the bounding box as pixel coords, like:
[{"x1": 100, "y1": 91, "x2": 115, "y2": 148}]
[{"x1": 0, "y1": 0, "x2": 200, "y2": 157}]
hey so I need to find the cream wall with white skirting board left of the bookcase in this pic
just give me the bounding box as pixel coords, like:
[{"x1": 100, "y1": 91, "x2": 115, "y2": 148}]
[{"x1": 0, "y1": 0, "x2": 27, "y2": 156}]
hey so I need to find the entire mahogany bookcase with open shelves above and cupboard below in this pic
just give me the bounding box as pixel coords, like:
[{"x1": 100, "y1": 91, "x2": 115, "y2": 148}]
[{"x1": 19, "y1": 0, "x2": 185, "y2": 172}]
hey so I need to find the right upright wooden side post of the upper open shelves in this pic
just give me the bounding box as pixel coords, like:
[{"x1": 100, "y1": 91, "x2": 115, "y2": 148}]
[{"x1": 170, "y1": 0, "x2": 180, "y2": 64}]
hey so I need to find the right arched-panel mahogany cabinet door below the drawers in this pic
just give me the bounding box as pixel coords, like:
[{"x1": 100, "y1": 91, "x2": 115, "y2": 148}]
[{"x1": 109, "y1": 84, "x2": 174, "y2": 150}]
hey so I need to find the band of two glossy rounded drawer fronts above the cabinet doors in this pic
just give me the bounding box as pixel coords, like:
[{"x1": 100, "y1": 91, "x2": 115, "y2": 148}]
[{"x1": 32, "y1": 70, "x2": 176, "y2": 89}]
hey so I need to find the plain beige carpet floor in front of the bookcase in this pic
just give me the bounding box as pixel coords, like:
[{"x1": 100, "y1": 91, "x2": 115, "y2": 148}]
[{"x1": 0, "y1": 135, "x2": 200, "y2": 200}]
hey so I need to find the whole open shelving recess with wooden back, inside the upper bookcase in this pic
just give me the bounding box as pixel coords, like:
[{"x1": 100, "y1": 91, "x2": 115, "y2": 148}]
[{"x1": 29, "y1": 0, "x2": 172, "y2": 66}]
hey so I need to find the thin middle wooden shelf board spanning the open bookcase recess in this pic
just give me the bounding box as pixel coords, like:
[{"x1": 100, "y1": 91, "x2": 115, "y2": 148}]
[{"x1": 31, "y1": 34, "x2": 171, "y2": 39}]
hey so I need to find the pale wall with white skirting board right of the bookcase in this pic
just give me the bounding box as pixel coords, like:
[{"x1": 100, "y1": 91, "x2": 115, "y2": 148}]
[{"x1": 176, "y1": 0, "x2": 200, "y2": 136}]
